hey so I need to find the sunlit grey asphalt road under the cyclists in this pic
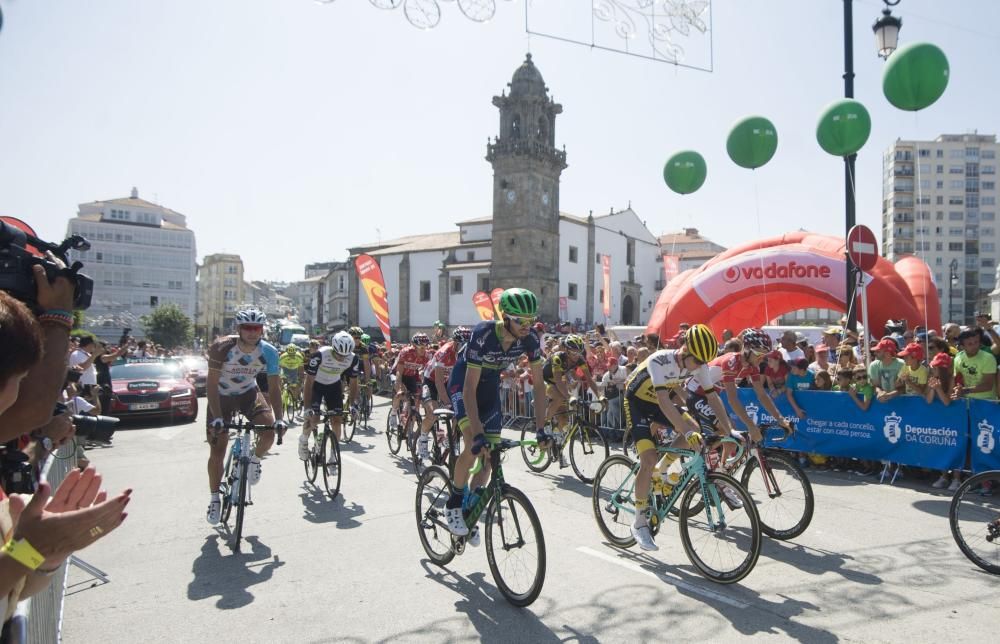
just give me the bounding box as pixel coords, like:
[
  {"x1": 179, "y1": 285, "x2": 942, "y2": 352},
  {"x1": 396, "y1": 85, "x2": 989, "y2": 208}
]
[{"x1": 63, "y1": 398, "x2": 1000, "y2": 643}]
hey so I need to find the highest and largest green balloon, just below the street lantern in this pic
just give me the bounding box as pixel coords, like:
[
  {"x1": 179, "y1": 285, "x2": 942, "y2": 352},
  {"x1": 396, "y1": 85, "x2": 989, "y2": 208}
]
[{"x1": 882, "y1": 42, "x2": 949, "y2": 112}]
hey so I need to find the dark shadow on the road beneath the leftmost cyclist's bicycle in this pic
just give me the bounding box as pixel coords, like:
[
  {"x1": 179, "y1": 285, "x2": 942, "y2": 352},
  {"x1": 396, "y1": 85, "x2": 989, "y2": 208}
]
[{"x1": 187, "y1": 534, "x2": 285, "y2": 610}]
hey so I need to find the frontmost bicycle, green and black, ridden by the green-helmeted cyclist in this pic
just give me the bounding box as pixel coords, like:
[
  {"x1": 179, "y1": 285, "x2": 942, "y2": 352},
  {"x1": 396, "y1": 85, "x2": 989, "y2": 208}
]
[{"x1": 416, "y1": 435, "x2": 545, "y2": 606}]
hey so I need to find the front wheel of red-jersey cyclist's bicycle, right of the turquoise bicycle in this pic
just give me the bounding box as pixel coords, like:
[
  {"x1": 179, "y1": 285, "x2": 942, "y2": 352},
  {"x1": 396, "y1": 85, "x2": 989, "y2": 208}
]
[{"x1": 740, "y1": 452, "x2": 813, "y2": 540}]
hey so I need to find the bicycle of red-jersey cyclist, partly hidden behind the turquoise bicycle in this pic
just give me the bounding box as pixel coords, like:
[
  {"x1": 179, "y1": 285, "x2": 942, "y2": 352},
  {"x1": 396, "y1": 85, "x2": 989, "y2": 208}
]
[{"x1": 709, "y1": 425, "x2": 815, "y2": 541}]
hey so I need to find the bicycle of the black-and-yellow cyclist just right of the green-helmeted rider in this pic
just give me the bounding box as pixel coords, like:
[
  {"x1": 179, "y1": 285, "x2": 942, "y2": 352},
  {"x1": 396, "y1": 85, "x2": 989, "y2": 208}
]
[{"x1": 521, "y1": 398, "x2": 611, "y2": 483}]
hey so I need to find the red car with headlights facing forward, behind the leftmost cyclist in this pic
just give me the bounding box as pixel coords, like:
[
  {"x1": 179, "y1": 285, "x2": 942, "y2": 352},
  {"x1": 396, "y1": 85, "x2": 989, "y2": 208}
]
[{"x1": 105, "y1": 360, "x2": 198, "y2": 422}]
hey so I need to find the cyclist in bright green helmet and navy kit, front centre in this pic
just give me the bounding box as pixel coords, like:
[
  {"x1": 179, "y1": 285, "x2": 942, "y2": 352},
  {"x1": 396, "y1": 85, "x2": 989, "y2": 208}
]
[{"x1": 445, "y1": 288, "x2": 550, "y2": 546}]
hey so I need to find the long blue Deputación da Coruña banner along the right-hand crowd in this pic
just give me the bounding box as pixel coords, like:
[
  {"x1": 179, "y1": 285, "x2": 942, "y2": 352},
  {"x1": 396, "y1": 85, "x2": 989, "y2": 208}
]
[{"x1": 722, "y1": 388, "x2": 968, "y2": 470}]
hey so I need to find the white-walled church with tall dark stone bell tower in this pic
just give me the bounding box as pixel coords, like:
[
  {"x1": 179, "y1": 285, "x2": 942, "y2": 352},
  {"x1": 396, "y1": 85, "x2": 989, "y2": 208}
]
[{"x1": 348, "y1": 54, "x2": 663, "y2": 341}]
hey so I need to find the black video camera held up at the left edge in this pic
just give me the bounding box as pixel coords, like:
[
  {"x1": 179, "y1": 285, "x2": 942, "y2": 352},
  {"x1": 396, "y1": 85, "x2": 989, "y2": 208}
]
[{"x1": 0, "y1": 219, "x2": 94, "y2": 311}]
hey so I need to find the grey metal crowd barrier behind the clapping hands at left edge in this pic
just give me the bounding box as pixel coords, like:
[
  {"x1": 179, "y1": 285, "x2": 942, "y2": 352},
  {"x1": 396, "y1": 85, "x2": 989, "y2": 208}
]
[{"x1": 6, "y1": 441, "x2": 76, "y2": 644}]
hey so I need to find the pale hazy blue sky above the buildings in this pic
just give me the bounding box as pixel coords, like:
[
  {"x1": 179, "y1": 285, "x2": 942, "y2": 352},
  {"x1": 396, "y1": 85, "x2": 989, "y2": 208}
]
[{"x1": 0, "y1": 0, "x2": 1000, "y2": 280}]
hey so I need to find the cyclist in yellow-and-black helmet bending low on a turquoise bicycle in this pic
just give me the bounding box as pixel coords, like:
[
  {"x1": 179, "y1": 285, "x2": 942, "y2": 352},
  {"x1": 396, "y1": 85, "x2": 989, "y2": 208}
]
[{"x1": 624, "y1": 324, "x2": 728, "y2": 550}]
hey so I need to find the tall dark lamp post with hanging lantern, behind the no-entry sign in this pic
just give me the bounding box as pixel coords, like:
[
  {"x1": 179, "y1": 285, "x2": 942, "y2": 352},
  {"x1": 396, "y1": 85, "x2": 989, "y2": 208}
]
[{"x1": 844, "y1": 0, "x2": 903, "y2": 331}]
